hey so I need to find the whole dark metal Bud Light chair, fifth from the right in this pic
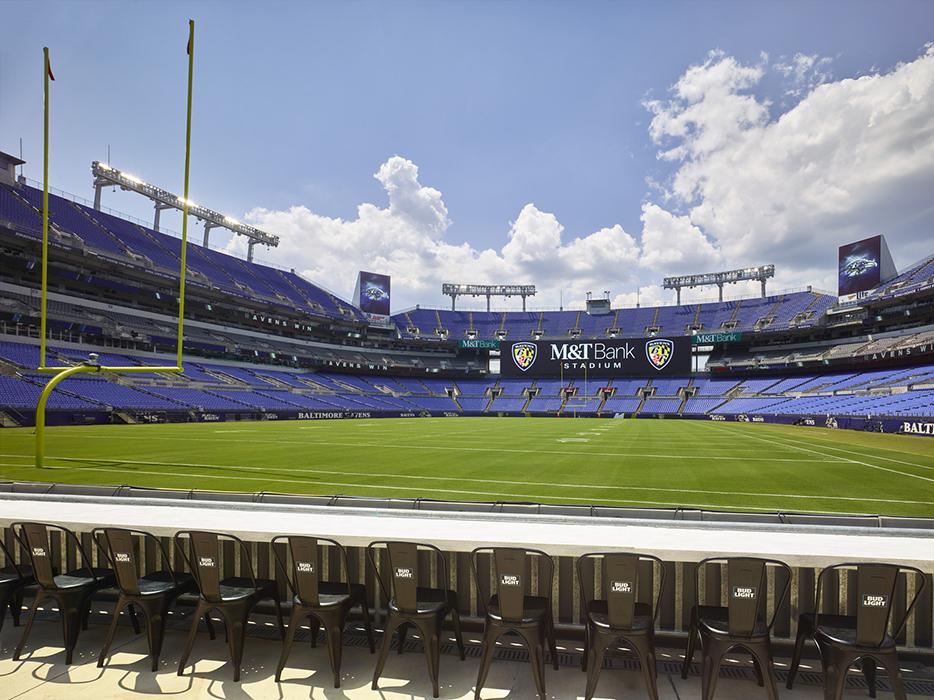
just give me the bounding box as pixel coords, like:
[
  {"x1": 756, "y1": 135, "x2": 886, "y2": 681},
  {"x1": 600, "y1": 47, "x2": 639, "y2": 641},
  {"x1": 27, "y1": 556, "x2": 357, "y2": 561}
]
[{"x1": 366, "y1": 541, "x2": 464, "y2": 697}]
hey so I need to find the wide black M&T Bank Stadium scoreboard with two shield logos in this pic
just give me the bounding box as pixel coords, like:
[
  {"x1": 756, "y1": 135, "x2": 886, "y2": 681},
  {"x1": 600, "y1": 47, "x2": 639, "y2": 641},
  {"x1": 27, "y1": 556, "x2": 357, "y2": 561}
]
[{"x1": 500, "y1": 336, "x2": 691, "y2": 379}]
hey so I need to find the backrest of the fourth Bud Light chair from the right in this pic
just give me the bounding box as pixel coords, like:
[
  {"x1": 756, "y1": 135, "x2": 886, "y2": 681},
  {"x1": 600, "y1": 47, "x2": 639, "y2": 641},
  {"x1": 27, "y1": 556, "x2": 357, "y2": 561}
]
[{"x1": 470, "y1": 547, "x2": 555, "y2": 621}]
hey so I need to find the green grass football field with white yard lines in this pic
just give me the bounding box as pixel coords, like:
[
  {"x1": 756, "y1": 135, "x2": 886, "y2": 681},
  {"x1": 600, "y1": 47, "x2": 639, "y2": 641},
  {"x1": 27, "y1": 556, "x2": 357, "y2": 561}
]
[{"x1": 0, "y1": 418, "x2": 934, "y2": 517}]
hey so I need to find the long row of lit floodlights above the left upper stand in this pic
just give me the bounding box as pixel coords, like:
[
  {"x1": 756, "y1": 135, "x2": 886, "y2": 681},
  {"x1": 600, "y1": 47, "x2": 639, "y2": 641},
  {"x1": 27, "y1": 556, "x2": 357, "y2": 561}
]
[{"x1": 91, "y1": 160, "x2": 279, "y2": 262}]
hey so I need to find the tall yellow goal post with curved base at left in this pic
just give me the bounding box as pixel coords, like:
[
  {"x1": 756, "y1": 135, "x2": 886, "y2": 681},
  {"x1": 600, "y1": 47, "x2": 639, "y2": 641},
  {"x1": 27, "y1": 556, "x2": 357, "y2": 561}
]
[{"x1": 35, "y1": 19, "x2": 195, "y2": 469}]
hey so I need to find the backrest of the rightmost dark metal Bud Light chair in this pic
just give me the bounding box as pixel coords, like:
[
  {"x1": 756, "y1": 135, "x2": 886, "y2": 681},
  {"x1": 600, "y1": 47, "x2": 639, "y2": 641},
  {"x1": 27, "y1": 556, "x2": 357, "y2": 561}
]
[{"x1": 816, "y1": 562, "x2": 927, "y2": 647}]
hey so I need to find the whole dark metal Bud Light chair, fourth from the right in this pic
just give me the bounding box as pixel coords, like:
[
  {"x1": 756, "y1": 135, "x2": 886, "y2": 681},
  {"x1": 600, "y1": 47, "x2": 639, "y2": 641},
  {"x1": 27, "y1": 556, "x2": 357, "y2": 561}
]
[{"x1": 470, "y1": 547, "x2": 558, "y2": 700}]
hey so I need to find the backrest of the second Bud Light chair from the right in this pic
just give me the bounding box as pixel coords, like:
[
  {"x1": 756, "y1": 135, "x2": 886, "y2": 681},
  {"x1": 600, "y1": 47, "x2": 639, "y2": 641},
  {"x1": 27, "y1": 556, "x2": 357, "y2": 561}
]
[{"x1": 694, "y1": 557, "x2": 791, "y2": 637}]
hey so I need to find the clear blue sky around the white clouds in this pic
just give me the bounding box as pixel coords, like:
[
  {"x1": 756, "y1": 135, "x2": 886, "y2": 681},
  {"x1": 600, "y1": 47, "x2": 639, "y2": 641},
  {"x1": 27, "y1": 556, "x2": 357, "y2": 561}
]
[{"x1": 0, "y1": 1, "x2": 934, "y2": 308}]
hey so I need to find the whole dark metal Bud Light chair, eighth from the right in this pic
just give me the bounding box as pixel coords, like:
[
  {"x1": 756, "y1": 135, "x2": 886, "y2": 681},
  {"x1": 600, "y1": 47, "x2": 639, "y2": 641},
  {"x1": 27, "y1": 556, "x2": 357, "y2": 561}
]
[{"x1": 93, "y1": 528, "x2": 201, "y2": 671}]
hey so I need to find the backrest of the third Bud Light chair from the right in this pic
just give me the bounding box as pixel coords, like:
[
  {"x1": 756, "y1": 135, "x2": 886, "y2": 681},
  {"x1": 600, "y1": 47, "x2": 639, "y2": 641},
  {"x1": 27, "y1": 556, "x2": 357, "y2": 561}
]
[{"x1": 577, "y1": 552, "x2": 665, "y2": 630}]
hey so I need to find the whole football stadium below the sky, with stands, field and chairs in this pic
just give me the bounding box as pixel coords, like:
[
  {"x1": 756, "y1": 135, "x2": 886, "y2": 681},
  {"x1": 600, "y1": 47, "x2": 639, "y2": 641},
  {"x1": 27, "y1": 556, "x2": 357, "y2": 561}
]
[{"x1": 0, "y1": 4, "x2": 934, "y2": 700}]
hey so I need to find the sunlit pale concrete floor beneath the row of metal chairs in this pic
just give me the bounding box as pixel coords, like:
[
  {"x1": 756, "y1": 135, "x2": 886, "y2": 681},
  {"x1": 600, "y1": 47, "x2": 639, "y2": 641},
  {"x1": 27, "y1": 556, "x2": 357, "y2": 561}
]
[{"x1": 0, "y1": 606, "x2": 934, "y2": 700}]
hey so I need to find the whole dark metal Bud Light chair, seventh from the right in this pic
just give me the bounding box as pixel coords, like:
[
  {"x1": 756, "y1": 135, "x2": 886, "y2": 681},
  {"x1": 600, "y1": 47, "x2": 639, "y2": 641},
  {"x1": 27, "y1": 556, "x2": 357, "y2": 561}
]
[{"x1": 175, "y1": 530, "x2": 285, "y2": 683}]
